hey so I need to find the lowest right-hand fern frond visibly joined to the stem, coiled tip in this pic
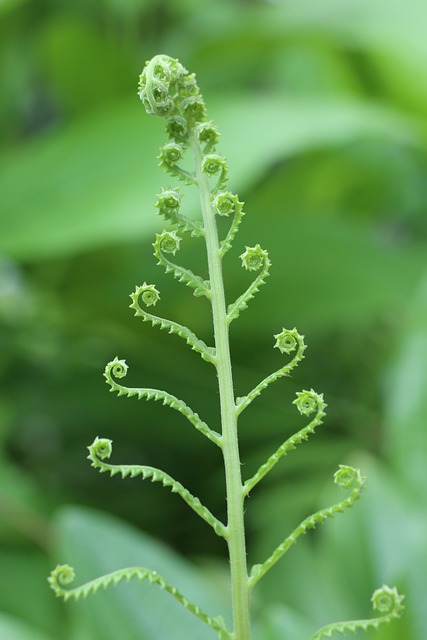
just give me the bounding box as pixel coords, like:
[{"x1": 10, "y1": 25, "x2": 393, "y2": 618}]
[{"x1": 249, "y1": 465, "x2": 365, "y2": 588}]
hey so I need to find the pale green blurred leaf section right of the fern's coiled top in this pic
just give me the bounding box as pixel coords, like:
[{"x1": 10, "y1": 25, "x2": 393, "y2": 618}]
[{"x1": 219, "y1": 95, "x2": 420, "y2": 188}]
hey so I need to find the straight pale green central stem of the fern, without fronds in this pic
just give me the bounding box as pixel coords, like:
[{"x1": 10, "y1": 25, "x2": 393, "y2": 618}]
[{"x1": 191, "y1": 136, "x2": 250, "y2": 640}]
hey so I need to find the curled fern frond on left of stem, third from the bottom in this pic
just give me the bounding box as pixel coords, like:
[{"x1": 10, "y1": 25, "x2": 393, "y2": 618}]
[{"x1": 104, "y1": 356, "x2": 222, "y2": 447}]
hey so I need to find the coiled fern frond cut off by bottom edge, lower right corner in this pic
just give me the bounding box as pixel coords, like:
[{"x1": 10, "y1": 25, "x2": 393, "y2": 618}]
[{"x1": 311, "y1": 585, "x2": 405, "y2": 640}]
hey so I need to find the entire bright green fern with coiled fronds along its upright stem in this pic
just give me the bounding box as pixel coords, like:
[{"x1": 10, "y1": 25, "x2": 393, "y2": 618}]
[{"x1": 49, "y1": 55, "x2": 403, "y2": 640}]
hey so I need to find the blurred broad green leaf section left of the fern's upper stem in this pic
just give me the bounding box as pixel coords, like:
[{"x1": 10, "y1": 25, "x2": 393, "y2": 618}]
[{"x1": 0, "y1": 99, "x2": 161, "y2": 259}]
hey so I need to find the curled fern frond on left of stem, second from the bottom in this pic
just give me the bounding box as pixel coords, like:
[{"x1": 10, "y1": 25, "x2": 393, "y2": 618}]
[{"x1": 88, "y1": 437, "x2": 226, "y2": 538}]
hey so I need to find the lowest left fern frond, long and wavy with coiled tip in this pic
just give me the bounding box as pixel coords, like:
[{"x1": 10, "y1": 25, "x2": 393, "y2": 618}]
[{"x1": 48, "y1": 564, "x2": 232, "y2": 640}]
